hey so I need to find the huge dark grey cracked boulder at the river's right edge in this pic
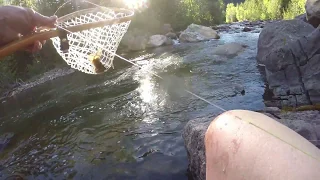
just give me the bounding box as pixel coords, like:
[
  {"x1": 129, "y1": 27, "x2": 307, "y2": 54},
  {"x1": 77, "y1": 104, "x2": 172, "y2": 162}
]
[{"x1": 257, "y1": 20, "x2": 320, "y2": 108}]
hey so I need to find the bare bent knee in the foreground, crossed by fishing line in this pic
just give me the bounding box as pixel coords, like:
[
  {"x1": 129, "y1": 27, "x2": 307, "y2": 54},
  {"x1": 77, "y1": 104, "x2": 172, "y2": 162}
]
[{"x1": 205, "y1": 110, "x2": 320, "y2": 180}]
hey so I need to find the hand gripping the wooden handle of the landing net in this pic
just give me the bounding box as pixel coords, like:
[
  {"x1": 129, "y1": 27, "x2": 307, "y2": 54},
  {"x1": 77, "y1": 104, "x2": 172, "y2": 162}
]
[{"x1": 0, "y1": 6, "x2": 57, "y2": 52}]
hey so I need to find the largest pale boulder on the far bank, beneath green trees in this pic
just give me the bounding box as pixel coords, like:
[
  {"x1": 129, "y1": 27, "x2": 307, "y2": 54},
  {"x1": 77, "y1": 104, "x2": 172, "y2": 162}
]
[{"x1": 179, "y1": 24, "x2": 220, "y2": 42}]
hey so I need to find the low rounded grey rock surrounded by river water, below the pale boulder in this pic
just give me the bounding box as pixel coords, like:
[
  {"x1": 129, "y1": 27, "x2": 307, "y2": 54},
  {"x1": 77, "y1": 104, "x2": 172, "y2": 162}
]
[{"x1": 213, "y1": 42, "x2": 246, "y2": 57}]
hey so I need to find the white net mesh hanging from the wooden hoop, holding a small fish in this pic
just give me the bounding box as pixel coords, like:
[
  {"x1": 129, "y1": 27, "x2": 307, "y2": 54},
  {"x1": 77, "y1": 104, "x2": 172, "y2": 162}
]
[{"x1": 51, "y1": 8, "x2": 130, "y2": 74}]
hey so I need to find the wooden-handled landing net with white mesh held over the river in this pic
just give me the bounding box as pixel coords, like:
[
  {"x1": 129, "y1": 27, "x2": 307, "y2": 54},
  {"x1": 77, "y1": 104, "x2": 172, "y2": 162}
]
[{"x1": 0, "y1": 7, "x2": 134, "y2": 74}]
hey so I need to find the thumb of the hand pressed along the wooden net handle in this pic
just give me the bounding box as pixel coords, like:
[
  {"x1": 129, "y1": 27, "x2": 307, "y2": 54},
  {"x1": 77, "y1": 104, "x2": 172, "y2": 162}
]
[{"x1": 31, "y1": 10, "x2": 58, "y2": 27}]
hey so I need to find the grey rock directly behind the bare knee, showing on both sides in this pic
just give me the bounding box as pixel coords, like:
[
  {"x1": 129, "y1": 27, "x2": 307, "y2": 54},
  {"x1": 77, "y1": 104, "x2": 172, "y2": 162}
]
[{"x1": 183, "y1": 108, "x2": 320, "y2": 180}]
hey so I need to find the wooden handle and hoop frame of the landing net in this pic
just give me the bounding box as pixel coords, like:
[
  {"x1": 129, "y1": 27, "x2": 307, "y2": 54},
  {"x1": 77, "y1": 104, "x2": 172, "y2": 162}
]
[{"x1": 0, "y1": 8, "x2": 134, "y2": 61}]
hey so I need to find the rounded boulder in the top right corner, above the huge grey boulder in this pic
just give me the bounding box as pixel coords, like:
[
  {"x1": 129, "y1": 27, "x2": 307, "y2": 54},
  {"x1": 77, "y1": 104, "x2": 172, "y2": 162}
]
[{"x1": 305, "y1": 0, "x2": 320, "y2": 27}]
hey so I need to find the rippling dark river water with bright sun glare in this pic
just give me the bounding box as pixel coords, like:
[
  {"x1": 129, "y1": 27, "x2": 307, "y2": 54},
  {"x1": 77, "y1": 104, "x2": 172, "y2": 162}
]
[{"x1": 0, "y1": 30, "x2": 264, "y2": 180}]
